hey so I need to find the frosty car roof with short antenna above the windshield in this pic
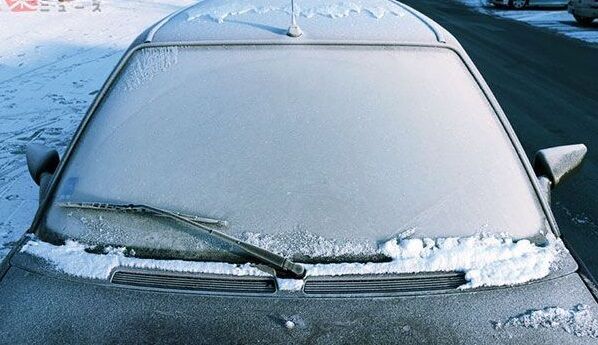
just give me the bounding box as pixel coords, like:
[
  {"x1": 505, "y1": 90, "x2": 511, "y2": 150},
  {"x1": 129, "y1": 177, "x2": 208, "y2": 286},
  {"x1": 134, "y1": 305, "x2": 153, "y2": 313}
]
[{"x1": 141, "y1": 0, "x2": 454, "y2": 45}]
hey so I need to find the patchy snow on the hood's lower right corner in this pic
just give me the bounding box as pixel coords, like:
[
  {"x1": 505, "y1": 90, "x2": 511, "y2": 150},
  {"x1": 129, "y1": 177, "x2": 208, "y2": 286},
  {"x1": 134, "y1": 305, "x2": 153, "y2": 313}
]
[{"x1": 495, "y1": 304, "x2": 598, "y2": 338}]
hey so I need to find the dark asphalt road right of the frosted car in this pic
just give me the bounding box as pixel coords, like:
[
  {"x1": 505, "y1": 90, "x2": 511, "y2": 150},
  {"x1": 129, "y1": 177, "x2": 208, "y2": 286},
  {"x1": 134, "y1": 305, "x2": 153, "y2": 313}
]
[{"x1": 403, "y1": 0, "x2": 598, "y2": 278}]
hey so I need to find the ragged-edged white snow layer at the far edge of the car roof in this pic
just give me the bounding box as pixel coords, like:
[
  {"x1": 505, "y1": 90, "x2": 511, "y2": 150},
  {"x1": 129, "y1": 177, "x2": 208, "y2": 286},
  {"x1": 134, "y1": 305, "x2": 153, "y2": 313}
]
[{"x1": 188, "y1": 0, "x2": 405, "y2": 23}]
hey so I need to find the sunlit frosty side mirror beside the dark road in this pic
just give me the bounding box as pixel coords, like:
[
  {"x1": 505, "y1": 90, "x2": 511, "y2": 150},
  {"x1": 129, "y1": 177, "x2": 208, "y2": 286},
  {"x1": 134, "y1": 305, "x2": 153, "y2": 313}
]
[{"x1": 534, "y1": 144, "x2": 588, "y2": 188}]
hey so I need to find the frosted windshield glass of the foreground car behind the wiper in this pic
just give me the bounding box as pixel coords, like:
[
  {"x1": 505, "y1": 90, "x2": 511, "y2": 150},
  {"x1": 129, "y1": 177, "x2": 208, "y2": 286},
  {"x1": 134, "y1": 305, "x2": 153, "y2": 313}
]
[{"x1": 46, "y1": 46, "x2": 545, "y2": 257}]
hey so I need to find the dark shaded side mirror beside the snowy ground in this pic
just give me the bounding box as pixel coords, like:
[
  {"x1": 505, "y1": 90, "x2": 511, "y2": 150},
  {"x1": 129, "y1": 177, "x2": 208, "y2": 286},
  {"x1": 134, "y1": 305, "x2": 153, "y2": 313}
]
[{"x1": 25, "y1": 144, "x2": 60, "y2": 202}]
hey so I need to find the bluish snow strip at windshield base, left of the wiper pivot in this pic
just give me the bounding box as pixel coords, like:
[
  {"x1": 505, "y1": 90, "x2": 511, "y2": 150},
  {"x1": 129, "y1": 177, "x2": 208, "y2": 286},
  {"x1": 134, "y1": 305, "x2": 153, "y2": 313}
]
[{"x1": 21, "y1": 239, "x2": 268, "y2": 279}]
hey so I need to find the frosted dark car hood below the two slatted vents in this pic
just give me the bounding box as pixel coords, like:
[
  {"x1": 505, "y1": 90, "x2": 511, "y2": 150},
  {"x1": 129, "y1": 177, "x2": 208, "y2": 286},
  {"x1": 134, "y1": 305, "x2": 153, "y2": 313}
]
[{"x1": 0, "y1": 254, "x2": 598, "y2": 344}]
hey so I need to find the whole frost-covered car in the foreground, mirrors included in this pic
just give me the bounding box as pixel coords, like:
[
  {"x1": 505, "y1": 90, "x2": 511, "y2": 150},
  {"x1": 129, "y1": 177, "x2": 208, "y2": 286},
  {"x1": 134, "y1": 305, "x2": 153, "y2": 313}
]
[{"x1": 0, "y1": 0, "x2": 598, "y2": 344}]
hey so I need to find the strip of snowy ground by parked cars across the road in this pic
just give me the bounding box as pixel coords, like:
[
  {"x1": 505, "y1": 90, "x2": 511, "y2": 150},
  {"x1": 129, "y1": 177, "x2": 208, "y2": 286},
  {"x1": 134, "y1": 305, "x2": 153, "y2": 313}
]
[{"x1": 457, "y1": 0, "x2": 598, "y2": 43}]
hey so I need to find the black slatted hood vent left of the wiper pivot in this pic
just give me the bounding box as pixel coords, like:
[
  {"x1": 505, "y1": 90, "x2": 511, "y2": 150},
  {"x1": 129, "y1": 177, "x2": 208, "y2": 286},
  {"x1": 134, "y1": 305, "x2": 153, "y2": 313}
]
[{"x1": 111, "y1": 271, "x2": 276, "y2": 293}]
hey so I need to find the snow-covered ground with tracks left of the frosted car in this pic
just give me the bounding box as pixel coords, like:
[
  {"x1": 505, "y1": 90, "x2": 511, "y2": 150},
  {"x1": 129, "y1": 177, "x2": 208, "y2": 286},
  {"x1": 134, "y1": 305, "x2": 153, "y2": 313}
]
[{"x1": 0, "y1": 0, "x2": 193, "y2": 260}]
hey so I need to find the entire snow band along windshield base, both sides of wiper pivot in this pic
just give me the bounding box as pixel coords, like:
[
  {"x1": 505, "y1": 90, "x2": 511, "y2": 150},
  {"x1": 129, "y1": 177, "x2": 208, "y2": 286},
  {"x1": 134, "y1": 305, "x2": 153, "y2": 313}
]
[{"x1": 21, "y1": 235, "x2": 566, "y2": 290}]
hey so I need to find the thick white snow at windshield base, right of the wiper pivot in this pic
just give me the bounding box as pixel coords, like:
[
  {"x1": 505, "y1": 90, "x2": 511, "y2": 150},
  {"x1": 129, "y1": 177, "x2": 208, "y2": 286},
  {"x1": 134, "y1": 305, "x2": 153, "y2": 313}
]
[{"x1": 306, "y1": 236, "x2": 566, "y2": 289}]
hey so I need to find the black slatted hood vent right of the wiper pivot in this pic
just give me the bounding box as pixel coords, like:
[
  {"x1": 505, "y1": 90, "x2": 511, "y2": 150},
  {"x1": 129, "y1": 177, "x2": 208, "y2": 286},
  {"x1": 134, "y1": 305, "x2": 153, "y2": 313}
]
[{"x1": 303, "y1": 272, "x2": 467, "y2": 294}]
